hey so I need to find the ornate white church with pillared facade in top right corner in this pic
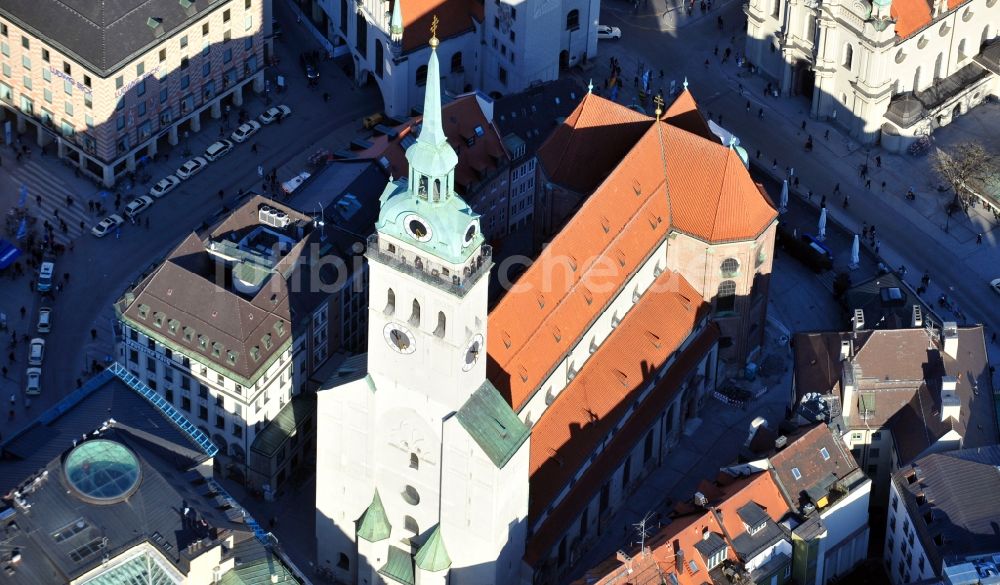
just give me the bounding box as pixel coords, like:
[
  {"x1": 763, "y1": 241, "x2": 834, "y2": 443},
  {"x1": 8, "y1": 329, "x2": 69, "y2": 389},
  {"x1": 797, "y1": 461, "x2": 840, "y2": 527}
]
[{"x1": 744, "y1": 0, "x2": 1000, "y2": 152}]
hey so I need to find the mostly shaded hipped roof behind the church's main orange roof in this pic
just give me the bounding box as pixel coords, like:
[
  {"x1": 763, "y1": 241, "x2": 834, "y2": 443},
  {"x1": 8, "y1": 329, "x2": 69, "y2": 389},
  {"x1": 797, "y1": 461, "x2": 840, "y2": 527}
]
[{"x1": 538, "y1": 93, "x2": 653, "y2": 193}]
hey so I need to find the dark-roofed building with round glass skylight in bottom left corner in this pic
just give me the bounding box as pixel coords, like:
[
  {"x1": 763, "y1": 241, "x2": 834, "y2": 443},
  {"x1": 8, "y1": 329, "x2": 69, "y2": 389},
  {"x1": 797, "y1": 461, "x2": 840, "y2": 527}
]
[{"x1": 0, "y1": 366, "x2": 298, "y2": 585}]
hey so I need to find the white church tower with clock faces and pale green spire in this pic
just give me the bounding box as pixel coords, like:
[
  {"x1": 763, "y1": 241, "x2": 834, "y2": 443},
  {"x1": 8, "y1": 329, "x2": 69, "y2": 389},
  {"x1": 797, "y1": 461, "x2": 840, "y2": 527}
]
[{"x1": 316, "y1": 24, "x2": 528, "y2": 585}]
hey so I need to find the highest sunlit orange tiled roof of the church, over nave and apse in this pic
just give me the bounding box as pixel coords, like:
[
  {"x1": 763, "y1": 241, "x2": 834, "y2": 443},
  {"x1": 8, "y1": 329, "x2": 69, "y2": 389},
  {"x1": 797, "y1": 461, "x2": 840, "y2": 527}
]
[{"x1": 487, "y1": 94, "x2": 777, "y2": 410}]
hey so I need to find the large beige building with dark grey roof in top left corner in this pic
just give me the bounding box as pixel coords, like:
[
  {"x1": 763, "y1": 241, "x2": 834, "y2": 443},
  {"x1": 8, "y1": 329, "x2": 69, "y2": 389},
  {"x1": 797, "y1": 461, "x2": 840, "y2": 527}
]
[{"x1": 0, "y1": 0, "x2": 271, "y2": 187}]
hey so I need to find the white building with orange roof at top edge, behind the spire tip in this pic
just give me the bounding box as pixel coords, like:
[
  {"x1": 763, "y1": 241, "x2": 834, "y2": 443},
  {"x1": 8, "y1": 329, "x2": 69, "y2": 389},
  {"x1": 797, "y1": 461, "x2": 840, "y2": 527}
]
[{"x1": 320, "y1": 0, "x2": 600, "y2": 117}]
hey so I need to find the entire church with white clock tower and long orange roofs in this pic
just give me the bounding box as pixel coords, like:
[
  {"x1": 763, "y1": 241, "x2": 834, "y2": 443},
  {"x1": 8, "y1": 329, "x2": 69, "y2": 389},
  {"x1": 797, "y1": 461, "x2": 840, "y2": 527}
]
[{"x1": 316, "y1": 37, "x2": 777, "y2": 585}]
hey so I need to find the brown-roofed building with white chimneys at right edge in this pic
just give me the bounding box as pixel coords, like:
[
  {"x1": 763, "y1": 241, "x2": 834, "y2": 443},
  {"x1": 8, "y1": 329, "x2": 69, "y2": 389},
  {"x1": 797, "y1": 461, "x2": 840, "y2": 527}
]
[{"x1": 793, "y1": 323, "x2": 997, "y2": 513}]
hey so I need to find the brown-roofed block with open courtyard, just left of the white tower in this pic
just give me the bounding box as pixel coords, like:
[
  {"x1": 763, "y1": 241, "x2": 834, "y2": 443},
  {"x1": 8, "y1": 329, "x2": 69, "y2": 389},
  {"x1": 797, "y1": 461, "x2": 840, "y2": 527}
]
[{"x1": 115, "y1": 196, "x2": 364, "y2": 490}]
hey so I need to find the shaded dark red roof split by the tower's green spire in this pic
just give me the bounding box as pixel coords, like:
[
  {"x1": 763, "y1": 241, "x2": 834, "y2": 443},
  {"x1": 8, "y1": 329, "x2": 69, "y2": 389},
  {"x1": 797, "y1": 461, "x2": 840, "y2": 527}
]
[{"x1": 359, "y1": 94, "x2": 510, "y2": 196}]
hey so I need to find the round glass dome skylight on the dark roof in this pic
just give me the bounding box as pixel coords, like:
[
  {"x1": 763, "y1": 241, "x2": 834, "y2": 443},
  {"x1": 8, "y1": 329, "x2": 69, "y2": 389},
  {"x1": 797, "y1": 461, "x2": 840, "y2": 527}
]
[{"x1": 63, "y1": 439, "x2": 140, "y2": 504}]
